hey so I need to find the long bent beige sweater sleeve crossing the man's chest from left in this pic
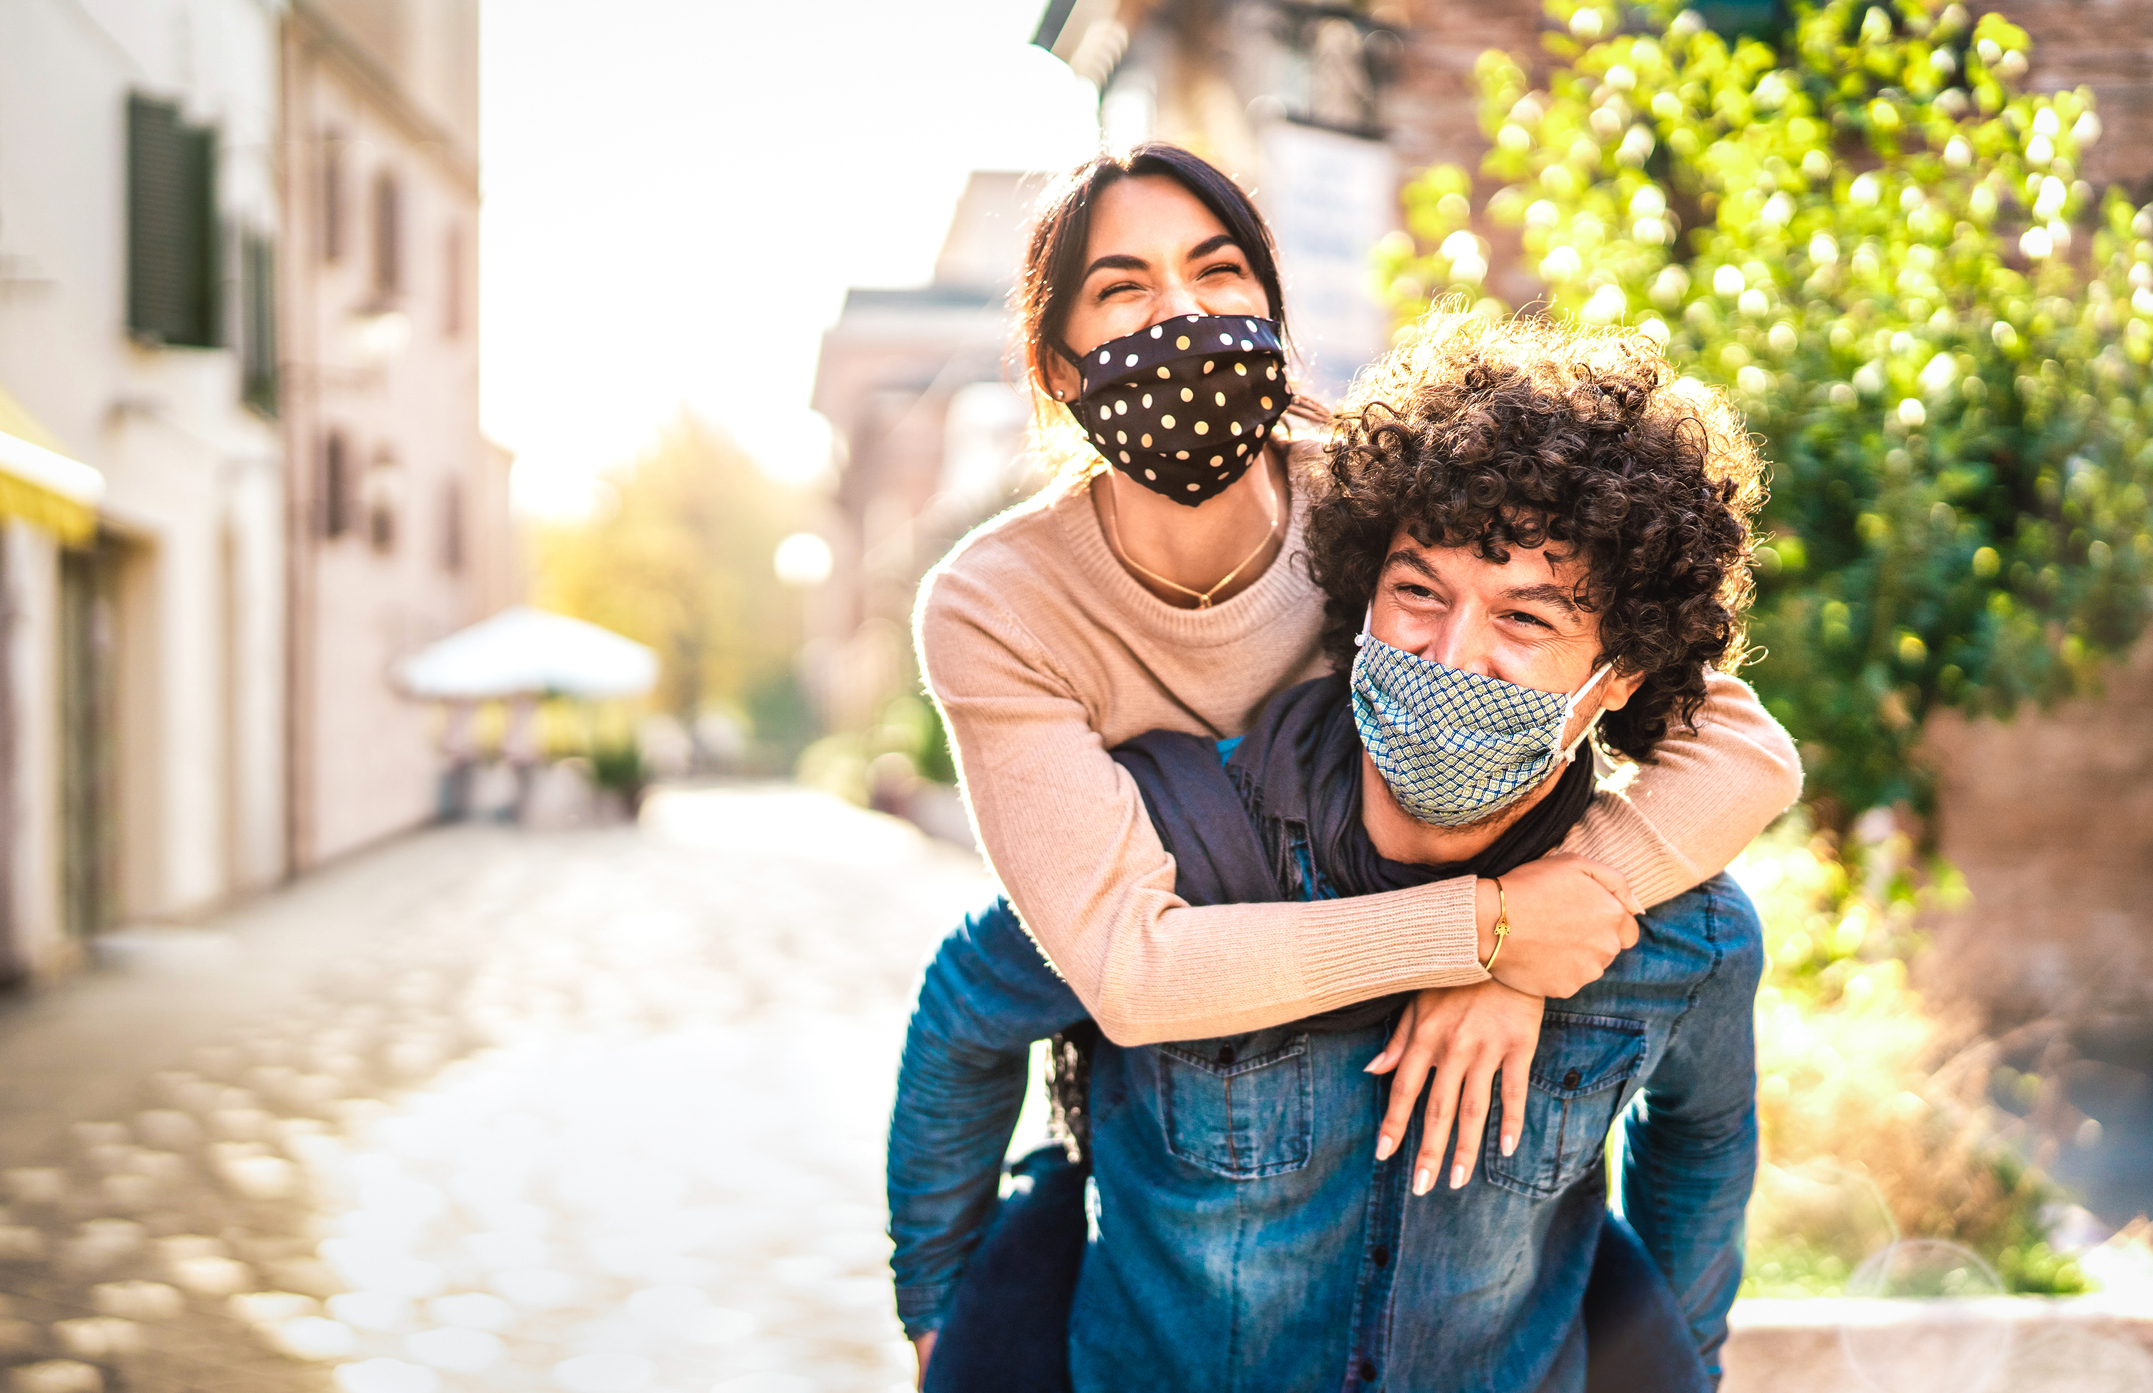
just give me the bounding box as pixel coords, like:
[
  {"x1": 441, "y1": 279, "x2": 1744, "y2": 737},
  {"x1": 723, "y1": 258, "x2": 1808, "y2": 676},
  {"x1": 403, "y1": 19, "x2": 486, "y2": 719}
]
[{"x1": 919, "y1": 571, "x2": 1486, "y2": 1046}]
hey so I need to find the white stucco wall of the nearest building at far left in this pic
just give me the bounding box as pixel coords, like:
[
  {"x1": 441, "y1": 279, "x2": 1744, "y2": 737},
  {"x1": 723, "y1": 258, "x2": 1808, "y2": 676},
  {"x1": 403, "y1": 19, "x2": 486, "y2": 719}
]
[{"x1": 0, "y1": 0, "x2": 284, "y2": 971}]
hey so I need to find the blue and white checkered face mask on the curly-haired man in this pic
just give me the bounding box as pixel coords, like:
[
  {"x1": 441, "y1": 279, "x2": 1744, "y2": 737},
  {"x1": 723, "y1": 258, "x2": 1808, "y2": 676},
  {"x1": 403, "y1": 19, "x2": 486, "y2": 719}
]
[{"x1": 1352, "y1": 622, "x2": 1613, "y2": 827}]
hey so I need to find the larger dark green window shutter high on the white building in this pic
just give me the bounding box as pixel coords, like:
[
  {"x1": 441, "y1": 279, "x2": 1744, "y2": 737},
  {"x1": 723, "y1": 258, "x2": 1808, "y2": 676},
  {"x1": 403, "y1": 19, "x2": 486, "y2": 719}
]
[{"x1": 127, "y1": 95, "x2": 222, "y2": 349}]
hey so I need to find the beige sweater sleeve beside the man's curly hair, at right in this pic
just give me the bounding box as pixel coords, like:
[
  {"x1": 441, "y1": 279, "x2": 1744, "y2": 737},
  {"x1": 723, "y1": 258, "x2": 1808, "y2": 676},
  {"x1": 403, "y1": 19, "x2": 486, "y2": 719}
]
[{"x1": 1563, "y1": 672, "x2": 1802, "y2": 906}]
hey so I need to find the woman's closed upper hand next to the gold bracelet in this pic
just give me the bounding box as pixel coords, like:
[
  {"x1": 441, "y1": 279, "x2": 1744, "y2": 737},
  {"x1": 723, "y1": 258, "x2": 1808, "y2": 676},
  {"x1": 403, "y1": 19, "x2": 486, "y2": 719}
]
[{"x1": 1477, "y1": 850, "x2": 1645, "y2": 997}]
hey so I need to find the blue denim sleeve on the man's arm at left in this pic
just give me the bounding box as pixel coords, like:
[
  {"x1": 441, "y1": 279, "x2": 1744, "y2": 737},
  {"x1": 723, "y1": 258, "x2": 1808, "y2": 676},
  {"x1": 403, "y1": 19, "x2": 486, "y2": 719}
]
[{"x1": 887, "y1": 900, "x2": 1083, "y2": 1365}]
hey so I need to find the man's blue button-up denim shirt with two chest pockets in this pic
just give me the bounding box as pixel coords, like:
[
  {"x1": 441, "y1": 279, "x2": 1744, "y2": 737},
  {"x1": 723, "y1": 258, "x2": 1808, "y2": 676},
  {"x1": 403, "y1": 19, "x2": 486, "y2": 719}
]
[{"x1": 889, "y1": 876, "x2": 1763, "y2": 1393}]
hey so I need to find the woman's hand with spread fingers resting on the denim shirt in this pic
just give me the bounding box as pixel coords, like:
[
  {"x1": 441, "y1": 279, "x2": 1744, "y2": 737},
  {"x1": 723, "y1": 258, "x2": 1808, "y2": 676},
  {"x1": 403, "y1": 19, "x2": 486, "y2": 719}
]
[{"x1": 1367, "y1": 982, "x2": 1544, "y2": 1195}]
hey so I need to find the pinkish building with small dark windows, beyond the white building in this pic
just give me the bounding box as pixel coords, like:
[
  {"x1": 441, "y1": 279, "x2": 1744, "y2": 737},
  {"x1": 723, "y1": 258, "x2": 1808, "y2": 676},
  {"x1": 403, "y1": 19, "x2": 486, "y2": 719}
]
[{"x1": 280, "y1": 0, "x2": 515, "y2": 870}]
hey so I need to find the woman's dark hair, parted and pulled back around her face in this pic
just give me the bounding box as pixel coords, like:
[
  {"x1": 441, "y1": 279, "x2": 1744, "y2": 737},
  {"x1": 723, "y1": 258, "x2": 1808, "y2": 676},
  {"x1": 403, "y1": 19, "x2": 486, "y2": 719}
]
[{"x1": 1014, "y1": 140, "x2": 1285, "y2": 411}]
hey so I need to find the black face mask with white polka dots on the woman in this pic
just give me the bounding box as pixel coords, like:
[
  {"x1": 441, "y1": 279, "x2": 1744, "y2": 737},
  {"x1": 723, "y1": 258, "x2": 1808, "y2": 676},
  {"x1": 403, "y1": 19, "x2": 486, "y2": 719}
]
[{"x1": 1074, "y1": 314, "x2": 1292, "y2": 508}]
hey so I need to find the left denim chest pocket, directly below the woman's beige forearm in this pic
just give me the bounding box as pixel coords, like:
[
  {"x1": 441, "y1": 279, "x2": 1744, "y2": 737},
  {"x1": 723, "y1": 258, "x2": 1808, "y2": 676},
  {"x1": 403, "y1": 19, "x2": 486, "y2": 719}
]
[{"x1": 1158, "y1": 1029, "x2": 1315, "y2": 1180}]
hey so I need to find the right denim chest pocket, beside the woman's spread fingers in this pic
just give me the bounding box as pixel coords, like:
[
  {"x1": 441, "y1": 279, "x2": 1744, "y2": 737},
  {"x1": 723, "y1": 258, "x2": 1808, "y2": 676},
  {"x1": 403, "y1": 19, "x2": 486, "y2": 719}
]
[{"x1": 1481, "y1": 1012, "x2": 1645, "y2": 1199}]
